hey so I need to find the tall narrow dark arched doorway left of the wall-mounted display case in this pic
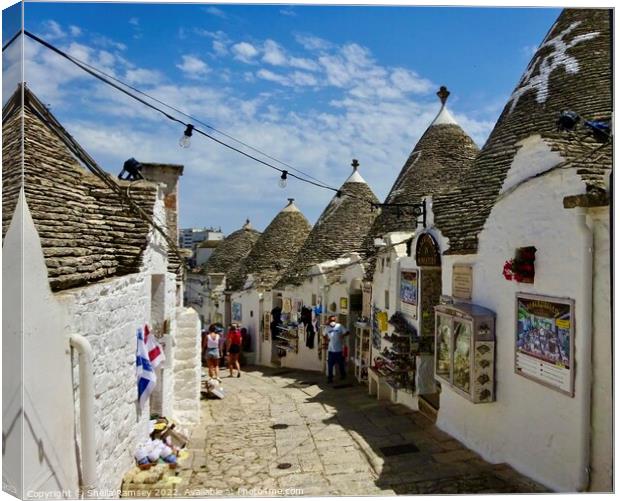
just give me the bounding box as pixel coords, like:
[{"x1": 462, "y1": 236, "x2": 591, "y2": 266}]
[{"x1": 415, "y1": 233, "x2": 441, "y2": 419}]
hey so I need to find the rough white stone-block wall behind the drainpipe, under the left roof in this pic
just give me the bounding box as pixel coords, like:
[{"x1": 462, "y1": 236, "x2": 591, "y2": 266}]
[{"x1": 56, "y1": 273, "x2": 151, "y2": 490}]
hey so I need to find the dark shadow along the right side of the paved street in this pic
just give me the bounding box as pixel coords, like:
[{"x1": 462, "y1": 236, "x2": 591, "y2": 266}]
[{"x1": 244, "y1": 367, "x2": 549, "y2": 494}]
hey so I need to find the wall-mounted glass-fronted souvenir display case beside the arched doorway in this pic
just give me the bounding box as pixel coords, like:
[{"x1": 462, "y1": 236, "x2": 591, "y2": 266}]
[{"x1": 435, "y1": 303, "x2": 495, "y2": 403}]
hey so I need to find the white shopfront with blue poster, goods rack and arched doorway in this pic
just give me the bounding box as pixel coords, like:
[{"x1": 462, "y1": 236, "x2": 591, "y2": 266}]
[{"x1": 369, "y1": 229, "x2": 441, "y2": 412}]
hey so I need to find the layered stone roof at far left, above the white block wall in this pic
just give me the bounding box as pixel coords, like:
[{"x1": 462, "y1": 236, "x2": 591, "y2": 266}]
[{"x1": 2, "y1": 85, "x2": 162, "y2": 291}]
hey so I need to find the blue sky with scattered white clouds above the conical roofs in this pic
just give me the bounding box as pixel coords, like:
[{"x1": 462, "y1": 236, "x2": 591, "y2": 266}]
[{"x1": 3, "y1": 2, "x2": 560, "y2": 233}]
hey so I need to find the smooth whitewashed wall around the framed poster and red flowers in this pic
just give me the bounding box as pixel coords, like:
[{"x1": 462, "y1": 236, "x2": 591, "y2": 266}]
[{"x1": 437, "y1": 152, "x2": 596, "y2": 491}]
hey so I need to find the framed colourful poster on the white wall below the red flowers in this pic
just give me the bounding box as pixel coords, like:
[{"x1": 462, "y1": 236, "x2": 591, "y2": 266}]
[{"x1": 515, "y1": 293, "x2": 575, "y2": 397}]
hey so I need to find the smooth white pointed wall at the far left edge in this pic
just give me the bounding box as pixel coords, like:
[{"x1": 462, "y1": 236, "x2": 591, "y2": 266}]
[{"x1": 8, "y1": 195, "x2": 79, "y2": 497}]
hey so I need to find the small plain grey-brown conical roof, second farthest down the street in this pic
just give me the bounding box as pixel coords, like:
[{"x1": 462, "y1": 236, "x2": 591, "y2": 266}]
[{"x1": 228, "y1": 198, "x2": 311, "y2": 290}]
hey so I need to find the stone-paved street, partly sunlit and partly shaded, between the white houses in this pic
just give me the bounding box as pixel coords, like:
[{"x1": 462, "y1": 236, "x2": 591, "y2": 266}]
[{"x1": 179, "y1": 368, "x2": 545, "y2": 497}]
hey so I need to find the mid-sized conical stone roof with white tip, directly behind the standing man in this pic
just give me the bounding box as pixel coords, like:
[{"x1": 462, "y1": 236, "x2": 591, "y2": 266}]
[{"x1": 277, "y1": 160, "x2": 378, "y2": 287}]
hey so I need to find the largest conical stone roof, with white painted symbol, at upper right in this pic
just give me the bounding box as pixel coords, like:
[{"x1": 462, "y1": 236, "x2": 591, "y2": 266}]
[{"x1": 433, "y1": 9, "x2": 612, "y2": 254}]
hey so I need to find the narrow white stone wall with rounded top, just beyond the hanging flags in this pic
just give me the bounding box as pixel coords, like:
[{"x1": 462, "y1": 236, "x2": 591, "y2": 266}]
[{"x1": 173, "y1": 308, "x2": 202, "y2": 425}]
